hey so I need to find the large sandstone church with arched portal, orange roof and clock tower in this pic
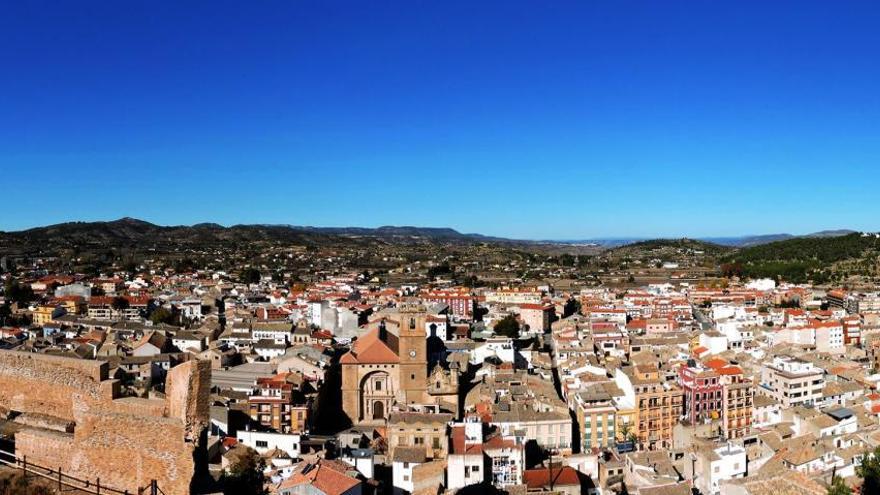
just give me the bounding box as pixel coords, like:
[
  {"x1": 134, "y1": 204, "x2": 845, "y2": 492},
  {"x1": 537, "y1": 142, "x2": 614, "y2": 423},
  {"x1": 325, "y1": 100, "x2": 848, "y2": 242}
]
[{"x1": 340, "y1": 302, "x2": 458, "y2": 425}]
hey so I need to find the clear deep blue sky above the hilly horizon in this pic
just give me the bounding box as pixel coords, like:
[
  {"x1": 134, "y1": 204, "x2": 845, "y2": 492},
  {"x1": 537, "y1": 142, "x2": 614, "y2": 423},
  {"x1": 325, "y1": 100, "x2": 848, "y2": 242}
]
[{"x1": 0, "y1": 0, "x2": 880, "y2": 239}]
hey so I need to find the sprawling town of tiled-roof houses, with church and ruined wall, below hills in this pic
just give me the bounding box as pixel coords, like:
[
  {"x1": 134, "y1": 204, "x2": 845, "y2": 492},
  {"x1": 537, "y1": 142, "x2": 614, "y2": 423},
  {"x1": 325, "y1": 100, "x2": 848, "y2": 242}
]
[{"x1": 0, "y1": 226, "x2": 880, "y2": 495}]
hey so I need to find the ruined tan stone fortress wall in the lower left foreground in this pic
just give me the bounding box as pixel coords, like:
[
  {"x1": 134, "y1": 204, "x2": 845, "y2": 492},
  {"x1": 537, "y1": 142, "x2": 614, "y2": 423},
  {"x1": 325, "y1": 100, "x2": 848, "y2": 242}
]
[{"x1": 0, "y1": 351, "x2": 211, "y2": 495}]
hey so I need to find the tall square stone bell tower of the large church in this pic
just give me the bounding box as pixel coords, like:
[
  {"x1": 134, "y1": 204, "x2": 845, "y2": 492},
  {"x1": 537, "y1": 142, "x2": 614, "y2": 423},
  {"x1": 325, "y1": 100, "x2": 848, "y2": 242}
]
[{"x1": 398, "y1": 303, "x2": 428, "y2": 404}]
